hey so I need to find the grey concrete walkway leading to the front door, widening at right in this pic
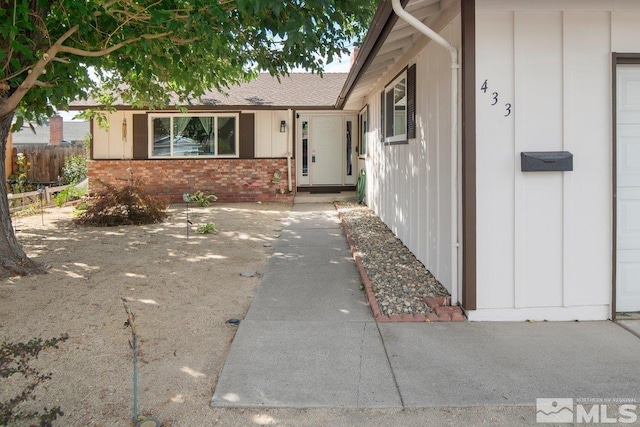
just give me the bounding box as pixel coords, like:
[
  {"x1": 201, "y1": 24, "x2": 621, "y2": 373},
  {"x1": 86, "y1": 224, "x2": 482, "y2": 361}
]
[{"x1": 211, "y1": 204, "x2": 640, "y2": 408}]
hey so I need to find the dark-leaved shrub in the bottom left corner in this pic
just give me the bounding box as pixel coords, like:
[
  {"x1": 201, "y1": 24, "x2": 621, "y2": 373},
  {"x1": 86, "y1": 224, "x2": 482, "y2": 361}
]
[{"x1": 0, "y1": 334, "x2": 69, "y2": 427}]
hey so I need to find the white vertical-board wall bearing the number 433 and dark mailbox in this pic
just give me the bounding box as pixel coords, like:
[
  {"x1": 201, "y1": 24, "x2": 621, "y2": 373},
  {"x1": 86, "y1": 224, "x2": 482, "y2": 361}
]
[{"x1": 476, "y1": 0, "x2": 640, "y2": 320}]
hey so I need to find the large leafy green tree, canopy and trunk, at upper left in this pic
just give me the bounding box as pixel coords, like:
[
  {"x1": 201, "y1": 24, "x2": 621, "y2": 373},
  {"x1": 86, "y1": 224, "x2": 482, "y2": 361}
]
[{"x1": 0, "y1": 0, "x2": 376, "y2": 277}]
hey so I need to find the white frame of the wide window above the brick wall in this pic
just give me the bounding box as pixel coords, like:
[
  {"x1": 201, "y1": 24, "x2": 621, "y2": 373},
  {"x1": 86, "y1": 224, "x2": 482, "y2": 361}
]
[{"x1": 147, "y1": 113, "x2": 240, "y2": 159}]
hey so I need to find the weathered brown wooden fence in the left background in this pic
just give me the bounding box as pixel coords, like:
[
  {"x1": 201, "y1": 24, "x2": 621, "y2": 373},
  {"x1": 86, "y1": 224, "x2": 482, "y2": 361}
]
[{"x1": 9, "y1": 145, "x2": 86, "y2": 183}]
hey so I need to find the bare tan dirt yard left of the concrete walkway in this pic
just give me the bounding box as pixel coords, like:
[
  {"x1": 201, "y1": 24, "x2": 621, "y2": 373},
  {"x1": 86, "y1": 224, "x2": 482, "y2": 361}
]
[{"x1": 0, "y1": 204, "x2": 531, "y2": 426}]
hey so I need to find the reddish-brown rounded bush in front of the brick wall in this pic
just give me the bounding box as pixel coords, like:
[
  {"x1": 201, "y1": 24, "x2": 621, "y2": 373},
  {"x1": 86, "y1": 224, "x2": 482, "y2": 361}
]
[{"x1": 74, "y1": 180, "x2": 169, "y2": 227}]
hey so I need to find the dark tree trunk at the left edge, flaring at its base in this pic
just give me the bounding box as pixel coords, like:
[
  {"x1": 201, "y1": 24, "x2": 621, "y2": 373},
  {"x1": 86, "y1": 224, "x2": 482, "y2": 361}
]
[{"x1": 0, "y1": 113, "x2": 46, "y2": 278}]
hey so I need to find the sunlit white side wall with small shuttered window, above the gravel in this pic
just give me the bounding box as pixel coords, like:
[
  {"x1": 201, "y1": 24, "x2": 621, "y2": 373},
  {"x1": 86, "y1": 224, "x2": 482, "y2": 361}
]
[{"x1": 366, "y1": 17, "x2": 460, "y2": 298}]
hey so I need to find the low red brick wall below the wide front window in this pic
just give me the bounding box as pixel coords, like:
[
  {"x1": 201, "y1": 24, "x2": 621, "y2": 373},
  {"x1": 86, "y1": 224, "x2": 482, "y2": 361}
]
[{"x1": 89, "y1": 159, "x2": 296, "y2": 203}]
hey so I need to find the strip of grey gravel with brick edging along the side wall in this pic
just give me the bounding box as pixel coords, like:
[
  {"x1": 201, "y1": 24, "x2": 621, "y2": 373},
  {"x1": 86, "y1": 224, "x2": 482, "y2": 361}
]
[{"x1": 336, "y1": 202, "x2": 449, "y2": 316}]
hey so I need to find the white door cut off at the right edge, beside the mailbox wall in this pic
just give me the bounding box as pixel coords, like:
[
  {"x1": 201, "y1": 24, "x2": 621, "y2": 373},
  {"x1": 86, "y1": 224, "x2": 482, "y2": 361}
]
[{"x1": 616, "y1": 65, "x2": 640, "y2": 312}]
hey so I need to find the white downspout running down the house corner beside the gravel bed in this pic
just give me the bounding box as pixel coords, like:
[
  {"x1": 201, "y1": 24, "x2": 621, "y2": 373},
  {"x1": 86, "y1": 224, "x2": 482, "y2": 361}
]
[{"x1": 391, "y1": 0, "x2": 460, "y2": 303}]
